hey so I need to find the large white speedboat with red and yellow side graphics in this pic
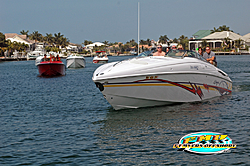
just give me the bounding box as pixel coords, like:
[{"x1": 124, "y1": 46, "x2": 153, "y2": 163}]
[{"x1": 92, "y1": 50, "x2": 232, "y2": 110}]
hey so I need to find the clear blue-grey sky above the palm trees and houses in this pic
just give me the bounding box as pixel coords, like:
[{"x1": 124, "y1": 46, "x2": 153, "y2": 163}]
[{"x1": 0, "y1": 0, "x2": 250, "y2": 44}]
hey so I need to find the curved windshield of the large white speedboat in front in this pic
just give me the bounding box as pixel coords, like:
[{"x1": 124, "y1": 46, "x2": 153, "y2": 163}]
[{"x1": 165, "y1": 49, "x2": 207, "y2": 62}]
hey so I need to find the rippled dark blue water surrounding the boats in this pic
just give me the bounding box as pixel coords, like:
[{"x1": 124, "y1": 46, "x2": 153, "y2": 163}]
[{"x1": 0, "y1": 55, "x2": 250, "y2": 165}]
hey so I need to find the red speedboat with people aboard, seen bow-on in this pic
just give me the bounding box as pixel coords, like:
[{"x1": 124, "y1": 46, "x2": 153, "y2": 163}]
[{"x1": 37, "y1": 57, "x2": 65, "y2": 76}]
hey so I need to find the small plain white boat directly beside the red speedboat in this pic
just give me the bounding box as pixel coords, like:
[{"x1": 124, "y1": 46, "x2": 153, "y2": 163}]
[{"x1": 66, "y1": 55, "x2": 86, "y2": 68}]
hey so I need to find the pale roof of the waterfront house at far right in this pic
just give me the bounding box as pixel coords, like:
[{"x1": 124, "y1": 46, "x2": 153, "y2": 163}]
[{"x1": 202, "y1": 31, "x2": 243, "y2": 40}]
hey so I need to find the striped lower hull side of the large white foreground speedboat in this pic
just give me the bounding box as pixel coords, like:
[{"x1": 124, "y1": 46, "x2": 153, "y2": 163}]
[{"x1": 95, "y1": 73, "x2": 232, "y2": 110}]
